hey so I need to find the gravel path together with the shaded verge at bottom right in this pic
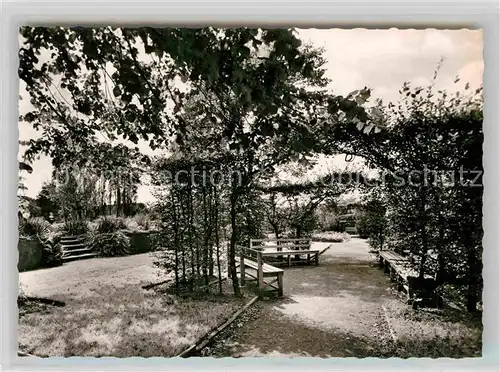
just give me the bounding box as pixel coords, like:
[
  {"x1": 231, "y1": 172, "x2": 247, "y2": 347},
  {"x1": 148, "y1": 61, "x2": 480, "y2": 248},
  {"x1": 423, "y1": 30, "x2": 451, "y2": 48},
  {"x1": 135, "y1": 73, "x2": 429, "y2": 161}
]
[{"x1": 212, "y1": 238, "x2": 481, "y2": 357}]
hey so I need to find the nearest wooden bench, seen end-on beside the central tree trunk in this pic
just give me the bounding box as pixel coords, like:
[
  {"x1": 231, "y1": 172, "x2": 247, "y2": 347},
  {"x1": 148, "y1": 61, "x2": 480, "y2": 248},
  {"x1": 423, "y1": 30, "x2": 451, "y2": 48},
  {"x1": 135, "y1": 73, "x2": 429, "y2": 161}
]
[{"x1": 236, "y1": 246, "x2": 284, "y2": 297}]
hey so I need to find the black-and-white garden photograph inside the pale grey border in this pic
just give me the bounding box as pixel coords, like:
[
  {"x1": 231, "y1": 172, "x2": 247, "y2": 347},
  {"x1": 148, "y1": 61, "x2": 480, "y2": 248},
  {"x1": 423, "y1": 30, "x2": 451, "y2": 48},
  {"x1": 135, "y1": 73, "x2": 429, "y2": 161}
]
[{"x1": 17, "y1": 24, "x2": 484, "y2": 358}]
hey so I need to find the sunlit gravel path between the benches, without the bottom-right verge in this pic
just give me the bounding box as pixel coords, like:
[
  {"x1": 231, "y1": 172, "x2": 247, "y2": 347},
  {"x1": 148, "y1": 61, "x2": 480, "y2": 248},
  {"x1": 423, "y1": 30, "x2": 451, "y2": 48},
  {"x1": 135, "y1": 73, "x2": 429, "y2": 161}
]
[{"x1": 205, "y1": 238, "x2": 403, "y2": 357}]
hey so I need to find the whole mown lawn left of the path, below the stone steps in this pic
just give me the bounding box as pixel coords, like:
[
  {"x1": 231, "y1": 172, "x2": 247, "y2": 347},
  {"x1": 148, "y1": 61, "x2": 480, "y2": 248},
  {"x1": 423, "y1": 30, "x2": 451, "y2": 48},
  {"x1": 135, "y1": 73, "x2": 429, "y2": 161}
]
[{"x1": 19, "y1": 254, "x2": 244, "y2": 357}]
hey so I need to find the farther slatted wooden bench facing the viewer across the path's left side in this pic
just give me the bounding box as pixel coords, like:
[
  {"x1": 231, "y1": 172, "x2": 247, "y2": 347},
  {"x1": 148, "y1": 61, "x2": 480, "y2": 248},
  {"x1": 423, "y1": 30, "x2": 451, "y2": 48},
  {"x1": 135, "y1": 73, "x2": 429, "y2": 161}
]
[{"x1": 250, "y1": 238, "x2": 320, "y2": 266}]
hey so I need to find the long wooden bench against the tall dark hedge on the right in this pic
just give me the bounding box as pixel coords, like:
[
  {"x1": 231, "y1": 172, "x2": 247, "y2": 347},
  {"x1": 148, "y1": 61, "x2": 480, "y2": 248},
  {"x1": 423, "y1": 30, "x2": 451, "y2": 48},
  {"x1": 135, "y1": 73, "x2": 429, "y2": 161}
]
[{"x1": 379, "y1": 251, "x2": 435, "y2": 302}]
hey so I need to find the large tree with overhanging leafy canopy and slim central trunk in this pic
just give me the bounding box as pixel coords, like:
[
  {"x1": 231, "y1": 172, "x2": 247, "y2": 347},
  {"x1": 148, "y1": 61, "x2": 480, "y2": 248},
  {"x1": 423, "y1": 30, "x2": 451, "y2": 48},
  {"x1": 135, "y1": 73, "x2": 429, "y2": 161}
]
[{"x1": 19, "y1": 27, "x2": 369, "y2": 294}]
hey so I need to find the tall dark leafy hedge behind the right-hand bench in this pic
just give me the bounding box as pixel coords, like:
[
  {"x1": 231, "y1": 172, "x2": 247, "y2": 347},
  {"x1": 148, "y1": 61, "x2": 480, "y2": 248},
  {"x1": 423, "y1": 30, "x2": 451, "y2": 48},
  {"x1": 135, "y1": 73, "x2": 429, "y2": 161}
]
[{"x1": 338, "y1": 77, "x2": 483, "y2": 311}]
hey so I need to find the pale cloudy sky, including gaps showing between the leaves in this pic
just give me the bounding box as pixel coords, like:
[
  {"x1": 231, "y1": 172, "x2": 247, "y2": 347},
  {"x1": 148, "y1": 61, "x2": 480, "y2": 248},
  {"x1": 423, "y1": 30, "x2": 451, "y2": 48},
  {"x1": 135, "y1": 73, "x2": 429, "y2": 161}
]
[{"x1": 19, "y1": 28, "x2": 484, "y2": 202}]
